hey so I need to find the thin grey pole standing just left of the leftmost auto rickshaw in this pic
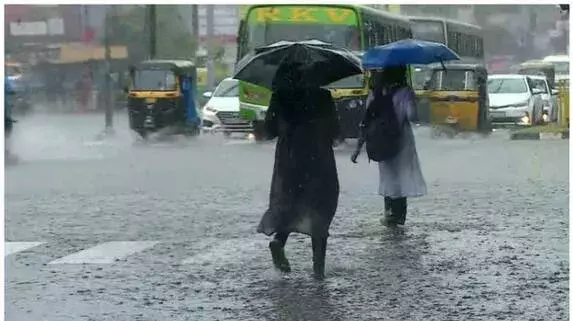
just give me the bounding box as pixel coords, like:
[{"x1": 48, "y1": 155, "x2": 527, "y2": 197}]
[{"x1": 103, "y1": 5, "x2": 116, "y2": 134}]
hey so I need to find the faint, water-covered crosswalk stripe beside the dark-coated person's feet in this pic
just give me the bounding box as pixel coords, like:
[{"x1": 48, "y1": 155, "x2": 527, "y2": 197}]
[{"x1": 181, "y1": 238, "x2": 268, "y2": 266}]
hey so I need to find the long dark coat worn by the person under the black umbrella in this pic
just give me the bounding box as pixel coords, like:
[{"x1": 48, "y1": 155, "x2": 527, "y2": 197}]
[{"x1": 257, "y1": 87, "x2": 339, "y2": 237}]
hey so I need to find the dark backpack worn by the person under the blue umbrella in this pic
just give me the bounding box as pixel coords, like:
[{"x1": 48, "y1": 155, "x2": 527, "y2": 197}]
[{"x1": 363, "y1": 90, "x2": 403, "y2": 162}]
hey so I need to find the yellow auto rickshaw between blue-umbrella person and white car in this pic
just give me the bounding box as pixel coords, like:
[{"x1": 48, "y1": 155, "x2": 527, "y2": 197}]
[{"x1": 424, "y1": 63, "x2": 492, "y2": 138}]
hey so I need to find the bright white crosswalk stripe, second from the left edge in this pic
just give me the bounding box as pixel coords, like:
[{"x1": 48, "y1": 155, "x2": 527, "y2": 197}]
[{"x1": 49, "y1": 242, "x2": 159, "y2": 264}]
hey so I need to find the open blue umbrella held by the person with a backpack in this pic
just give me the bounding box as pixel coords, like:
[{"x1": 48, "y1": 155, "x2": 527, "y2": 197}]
[{"x1": 362, "y1": 39, "x2": 460, "y2": 69}]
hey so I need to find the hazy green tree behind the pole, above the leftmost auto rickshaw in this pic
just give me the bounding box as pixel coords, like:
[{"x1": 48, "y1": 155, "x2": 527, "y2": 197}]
[{"x1": 102, "y1": 5, "x2": 197, "y2": 61}]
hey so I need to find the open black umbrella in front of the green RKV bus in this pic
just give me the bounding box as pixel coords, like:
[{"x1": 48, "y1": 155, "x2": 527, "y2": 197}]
[{"x1": 233, "y1": 40, "x2": 362, "y2": 88}]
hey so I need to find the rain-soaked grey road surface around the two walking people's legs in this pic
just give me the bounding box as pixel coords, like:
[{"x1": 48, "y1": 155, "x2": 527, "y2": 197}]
[{"x1": 5, "y1": 112, "x2": 569, "y2": 321}]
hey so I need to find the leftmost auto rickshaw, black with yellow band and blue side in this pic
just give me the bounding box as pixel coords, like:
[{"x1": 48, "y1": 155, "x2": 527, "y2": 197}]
[{"x1": 125, "y1": 60, "x2": 201, "y2": 139}]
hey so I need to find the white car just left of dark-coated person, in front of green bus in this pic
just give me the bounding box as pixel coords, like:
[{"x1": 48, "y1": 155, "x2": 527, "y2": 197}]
[{"x1": 202, "y1": 78, "x2": 252, "y2": 136}]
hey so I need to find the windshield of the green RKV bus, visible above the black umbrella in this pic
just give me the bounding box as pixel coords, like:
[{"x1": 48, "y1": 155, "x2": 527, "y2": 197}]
[{"x1": 248, "y1": 22, "x2": 360, "y2": 50}]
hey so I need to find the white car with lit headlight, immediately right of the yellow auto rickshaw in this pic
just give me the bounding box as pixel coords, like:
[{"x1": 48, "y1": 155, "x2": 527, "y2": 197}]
[{"x1": 487, "y1": 74, "x2": 544, "y2": 125}]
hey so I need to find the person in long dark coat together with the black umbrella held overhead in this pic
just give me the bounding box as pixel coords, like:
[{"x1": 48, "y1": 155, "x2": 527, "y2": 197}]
[{"x1": 233, "y1": 40, "x2": 362, "y2": 279}]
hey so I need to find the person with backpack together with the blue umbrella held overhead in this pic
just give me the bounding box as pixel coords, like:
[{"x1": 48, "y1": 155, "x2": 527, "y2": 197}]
[{"x1": 351, "y1": 39, "x2": 460, "y2": 226}]
